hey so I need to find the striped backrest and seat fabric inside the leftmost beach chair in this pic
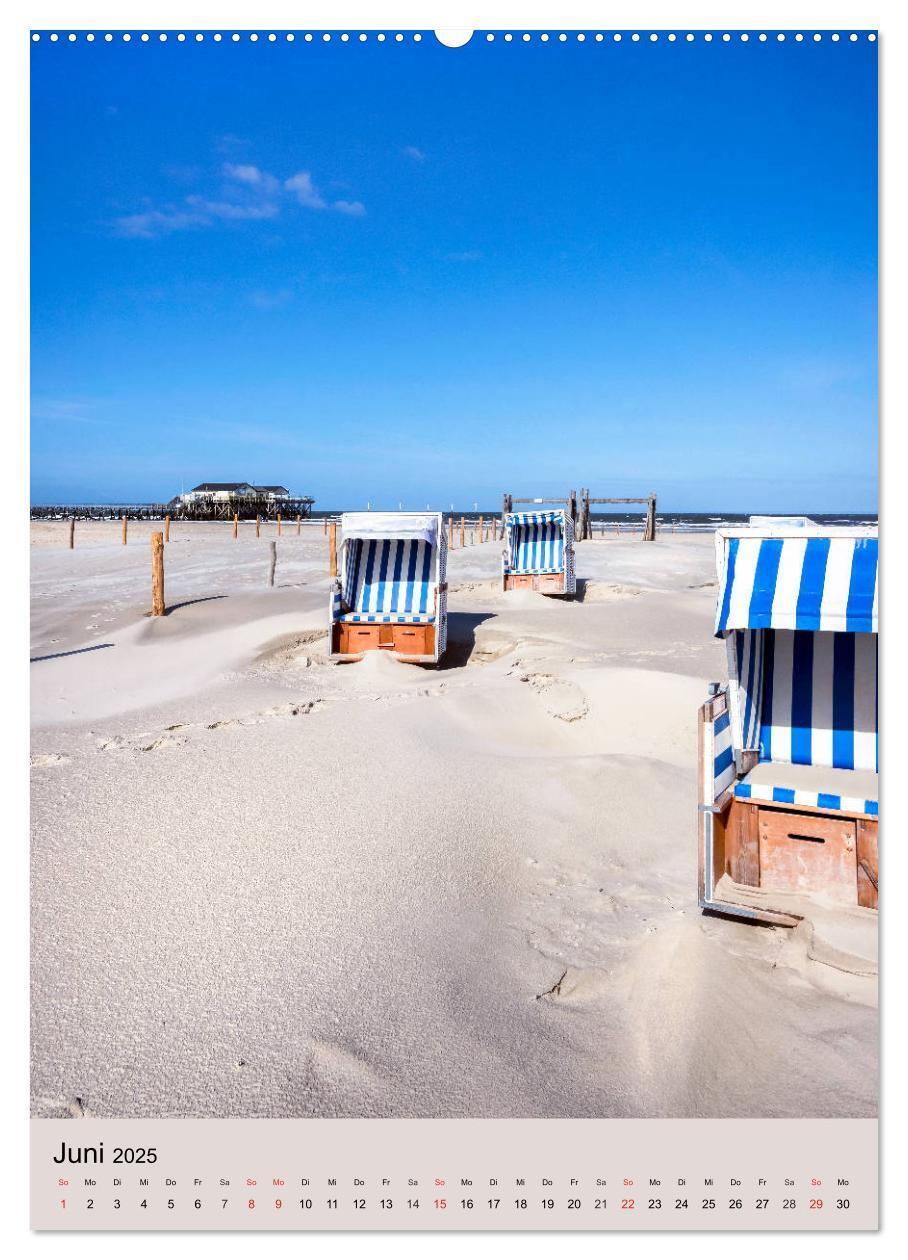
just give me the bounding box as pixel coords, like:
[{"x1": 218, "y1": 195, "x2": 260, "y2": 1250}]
[{"x1": 339, "y1": 538, "x2": 437, "y2": 625}]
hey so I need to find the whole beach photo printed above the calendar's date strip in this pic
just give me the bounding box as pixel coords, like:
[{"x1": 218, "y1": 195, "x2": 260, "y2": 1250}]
[{"x1": 30, "y1": 30, "x2": 880, "y2": 1119}]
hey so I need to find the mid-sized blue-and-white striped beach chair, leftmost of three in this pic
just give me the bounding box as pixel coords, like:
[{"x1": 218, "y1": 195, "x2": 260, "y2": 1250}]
[{"x1": 329, "y1": 512, "x2": 447, "y2": 664}]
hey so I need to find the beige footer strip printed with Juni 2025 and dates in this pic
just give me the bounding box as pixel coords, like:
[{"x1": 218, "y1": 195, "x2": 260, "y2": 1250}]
[{"x1": 31, "y1": 1118, "x2": 878, "y2": 1230}]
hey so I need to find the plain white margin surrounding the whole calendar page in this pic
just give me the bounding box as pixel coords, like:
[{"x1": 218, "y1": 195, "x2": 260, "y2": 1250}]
[{"x1": 0, "y1": 0, "x2": 908, "y2": 1260}]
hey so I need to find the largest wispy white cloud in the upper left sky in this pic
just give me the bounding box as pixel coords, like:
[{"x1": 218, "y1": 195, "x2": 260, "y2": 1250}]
[{"x1": 113, "y1": 161, "x2": 365, "y2": 239}]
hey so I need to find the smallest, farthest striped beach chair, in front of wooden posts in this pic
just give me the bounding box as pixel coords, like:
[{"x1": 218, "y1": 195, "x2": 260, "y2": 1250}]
[{"x1": 501, "y1": 508, "x2": 577, "y2": 595}]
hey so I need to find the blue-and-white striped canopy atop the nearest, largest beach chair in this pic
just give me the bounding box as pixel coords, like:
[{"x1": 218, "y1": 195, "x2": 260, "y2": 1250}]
[{"x1": 715, "y1": 530, "x2": 879, "y2": 636}]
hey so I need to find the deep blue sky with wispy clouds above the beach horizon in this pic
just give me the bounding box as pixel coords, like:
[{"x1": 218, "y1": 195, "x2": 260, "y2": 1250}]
[{"x1": 31, "y1": 34, "x2": 877, "y2": 512}]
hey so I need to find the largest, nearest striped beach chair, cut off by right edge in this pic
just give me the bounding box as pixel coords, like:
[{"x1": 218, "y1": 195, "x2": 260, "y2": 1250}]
[{"x1": 699, "y1": 520, "x2": 879, "y2": 921}]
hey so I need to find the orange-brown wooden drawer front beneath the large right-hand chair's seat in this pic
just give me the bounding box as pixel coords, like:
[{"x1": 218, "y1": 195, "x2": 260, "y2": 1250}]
[{"x1": 759, "y1": 809, "x2": 858, "y2": 906}]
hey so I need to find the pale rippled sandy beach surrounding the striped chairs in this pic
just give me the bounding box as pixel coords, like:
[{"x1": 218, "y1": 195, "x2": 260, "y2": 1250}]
[{"x1": 30, "y1": 522, "x2": 878, "y2": 1118}]
